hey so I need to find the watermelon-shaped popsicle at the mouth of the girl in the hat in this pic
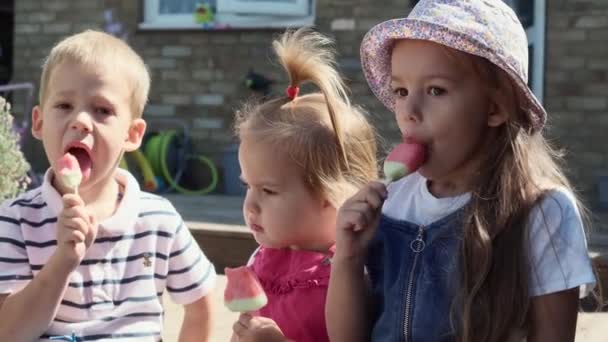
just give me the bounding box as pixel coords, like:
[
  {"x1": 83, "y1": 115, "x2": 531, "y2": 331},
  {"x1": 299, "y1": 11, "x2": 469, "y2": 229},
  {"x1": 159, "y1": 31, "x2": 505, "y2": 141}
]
[{"x1": 384, "y1": 142, "x2": 426, "y2": 183}]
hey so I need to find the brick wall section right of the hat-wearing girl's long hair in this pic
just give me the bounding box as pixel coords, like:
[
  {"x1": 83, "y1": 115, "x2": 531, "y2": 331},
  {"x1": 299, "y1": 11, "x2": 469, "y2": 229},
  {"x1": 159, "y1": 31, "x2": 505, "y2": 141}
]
[{"x1": 545, "y1": 0, "x2": 608, "y2": 229}]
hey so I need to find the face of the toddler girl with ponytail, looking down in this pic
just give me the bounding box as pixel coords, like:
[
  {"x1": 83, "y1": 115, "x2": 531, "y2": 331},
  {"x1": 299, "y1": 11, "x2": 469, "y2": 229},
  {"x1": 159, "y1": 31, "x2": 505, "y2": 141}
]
[{"x1": 239, "y1": 136, "x2": 336, "y2": 251}]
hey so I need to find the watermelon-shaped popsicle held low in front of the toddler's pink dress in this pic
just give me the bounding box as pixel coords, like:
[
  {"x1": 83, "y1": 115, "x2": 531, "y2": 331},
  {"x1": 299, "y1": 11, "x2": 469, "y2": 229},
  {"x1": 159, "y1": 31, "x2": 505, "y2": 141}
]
[{"x1": 224, "y1": 266, "x2": 268, "y2": 312}]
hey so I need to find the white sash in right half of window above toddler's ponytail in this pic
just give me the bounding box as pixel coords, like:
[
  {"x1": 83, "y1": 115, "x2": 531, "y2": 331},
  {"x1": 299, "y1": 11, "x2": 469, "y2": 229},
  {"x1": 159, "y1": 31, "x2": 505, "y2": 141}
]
[{"x1": 217, "y1": 0, "x2": 309, "y2": 17}]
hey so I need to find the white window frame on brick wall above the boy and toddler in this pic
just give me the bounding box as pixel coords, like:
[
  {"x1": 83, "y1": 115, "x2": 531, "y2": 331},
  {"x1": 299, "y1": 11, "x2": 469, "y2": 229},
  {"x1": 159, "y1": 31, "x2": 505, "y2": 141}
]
[{"x1": 139, "y1": 0, "x2": 317, "y2": 30}]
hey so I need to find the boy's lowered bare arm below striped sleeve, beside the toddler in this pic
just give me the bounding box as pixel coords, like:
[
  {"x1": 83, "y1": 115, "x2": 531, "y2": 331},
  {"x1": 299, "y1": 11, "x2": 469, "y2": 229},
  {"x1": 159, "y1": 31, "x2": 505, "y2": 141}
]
[{"x1": 179, "y1": 294, "x2": 211, "y2": 342}]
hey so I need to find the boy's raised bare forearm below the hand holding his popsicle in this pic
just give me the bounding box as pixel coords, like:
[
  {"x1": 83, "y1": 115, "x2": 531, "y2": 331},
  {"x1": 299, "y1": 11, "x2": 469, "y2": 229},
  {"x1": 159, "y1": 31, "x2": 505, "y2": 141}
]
[{"x1": 0, "y1": 253, "x2": 72, "y2": 341}]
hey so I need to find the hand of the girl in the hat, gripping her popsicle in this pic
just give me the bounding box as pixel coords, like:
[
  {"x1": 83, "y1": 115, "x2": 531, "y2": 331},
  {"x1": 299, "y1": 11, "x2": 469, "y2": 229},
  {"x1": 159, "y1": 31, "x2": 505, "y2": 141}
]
[{"x1": 334, "y1": 182, "x2": 387, "y2": 259}]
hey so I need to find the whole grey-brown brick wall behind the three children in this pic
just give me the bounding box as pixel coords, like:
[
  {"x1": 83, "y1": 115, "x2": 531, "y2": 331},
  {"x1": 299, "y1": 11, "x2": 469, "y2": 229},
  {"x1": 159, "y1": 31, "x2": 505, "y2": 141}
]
[{"x1": 8, "y1": 0, "x2": 608, "y2": 230}]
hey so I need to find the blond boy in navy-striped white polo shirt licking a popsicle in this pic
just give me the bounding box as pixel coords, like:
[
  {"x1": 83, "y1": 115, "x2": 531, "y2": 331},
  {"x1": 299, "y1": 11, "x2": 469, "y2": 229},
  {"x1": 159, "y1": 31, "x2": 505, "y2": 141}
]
[{"x1": 0, "y1": 31, "x2": 215, "y2": 342}]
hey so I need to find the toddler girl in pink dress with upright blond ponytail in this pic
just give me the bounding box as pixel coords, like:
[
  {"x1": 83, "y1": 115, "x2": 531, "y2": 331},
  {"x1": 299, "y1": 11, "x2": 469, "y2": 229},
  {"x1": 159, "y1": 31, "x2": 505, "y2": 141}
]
[{"x1": 232, "y1": 29, "x2": 377, "y2": 342}]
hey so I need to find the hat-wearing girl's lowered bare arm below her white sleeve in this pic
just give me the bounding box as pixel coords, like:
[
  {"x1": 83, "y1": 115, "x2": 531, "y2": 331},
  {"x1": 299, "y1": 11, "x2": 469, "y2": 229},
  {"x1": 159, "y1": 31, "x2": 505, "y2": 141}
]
[{"x1": 527, "y1": 287, "x2": 579, "y2": 342}]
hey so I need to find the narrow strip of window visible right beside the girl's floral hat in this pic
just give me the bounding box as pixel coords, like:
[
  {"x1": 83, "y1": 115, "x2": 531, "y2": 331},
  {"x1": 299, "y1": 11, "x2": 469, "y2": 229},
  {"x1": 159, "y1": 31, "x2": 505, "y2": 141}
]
[{"x1": 505, "y1": 0, "x2": 546, "y2": 102}]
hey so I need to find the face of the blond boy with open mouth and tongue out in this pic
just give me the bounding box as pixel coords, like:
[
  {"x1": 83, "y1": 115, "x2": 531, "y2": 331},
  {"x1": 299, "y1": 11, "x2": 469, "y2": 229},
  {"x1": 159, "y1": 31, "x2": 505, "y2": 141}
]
[{"x1": 32, "y1": 61, "x2": 146, "y2": 193}]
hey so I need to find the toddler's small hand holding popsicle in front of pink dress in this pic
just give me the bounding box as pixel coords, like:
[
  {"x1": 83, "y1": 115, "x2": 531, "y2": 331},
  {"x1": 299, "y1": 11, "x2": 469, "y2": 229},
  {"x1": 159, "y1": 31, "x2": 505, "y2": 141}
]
[{"x1": 230, "y1": 313, "x2": 288, "y2": 342}]
